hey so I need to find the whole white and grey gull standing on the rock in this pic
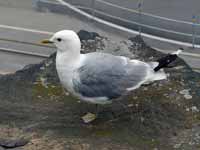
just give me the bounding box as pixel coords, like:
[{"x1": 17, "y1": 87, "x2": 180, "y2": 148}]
[{"x1": 42, "y1": 30, "x2": 181, "y2": 105}]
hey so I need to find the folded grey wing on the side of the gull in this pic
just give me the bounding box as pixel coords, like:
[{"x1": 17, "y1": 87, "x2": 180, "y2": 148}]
[{"x1": 73, "y1": 54, "x2": 147, "y2": 99}]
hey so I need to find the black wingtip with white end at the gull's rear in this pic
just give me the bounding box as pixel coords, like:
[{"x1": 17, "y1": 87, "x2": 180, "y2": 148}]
[{"x1": 154, "y1": 48, "x2": 183, "y2": 72}]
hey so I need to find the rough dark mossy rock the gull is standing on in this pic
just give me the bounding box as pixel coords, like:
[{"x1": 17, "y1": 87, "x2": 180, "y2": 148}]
[{"x1": 0, "y1": 30, "x2": 200, "y2": 150}]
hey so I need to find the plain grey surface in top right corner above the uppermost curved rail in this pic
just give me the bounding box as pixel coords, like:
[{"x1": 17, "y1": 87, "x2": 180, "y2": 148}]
[{"x1": 105, "y1": 0, "x2": 200, "y2": 22}]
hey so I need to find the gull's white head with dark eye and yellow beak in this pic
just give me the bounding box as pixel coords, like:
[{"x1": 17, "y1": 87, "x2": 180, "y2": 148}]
[{"x1": 42, "y1": 30, "x2": 81, "y2": 52}]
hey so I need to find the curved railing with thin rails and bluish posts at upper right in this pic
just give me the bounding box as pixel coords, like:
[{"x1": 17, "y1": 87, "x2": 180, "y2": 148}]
[{"x1": 65, "y1": 0, "x2": 200, "y2": 47}]
